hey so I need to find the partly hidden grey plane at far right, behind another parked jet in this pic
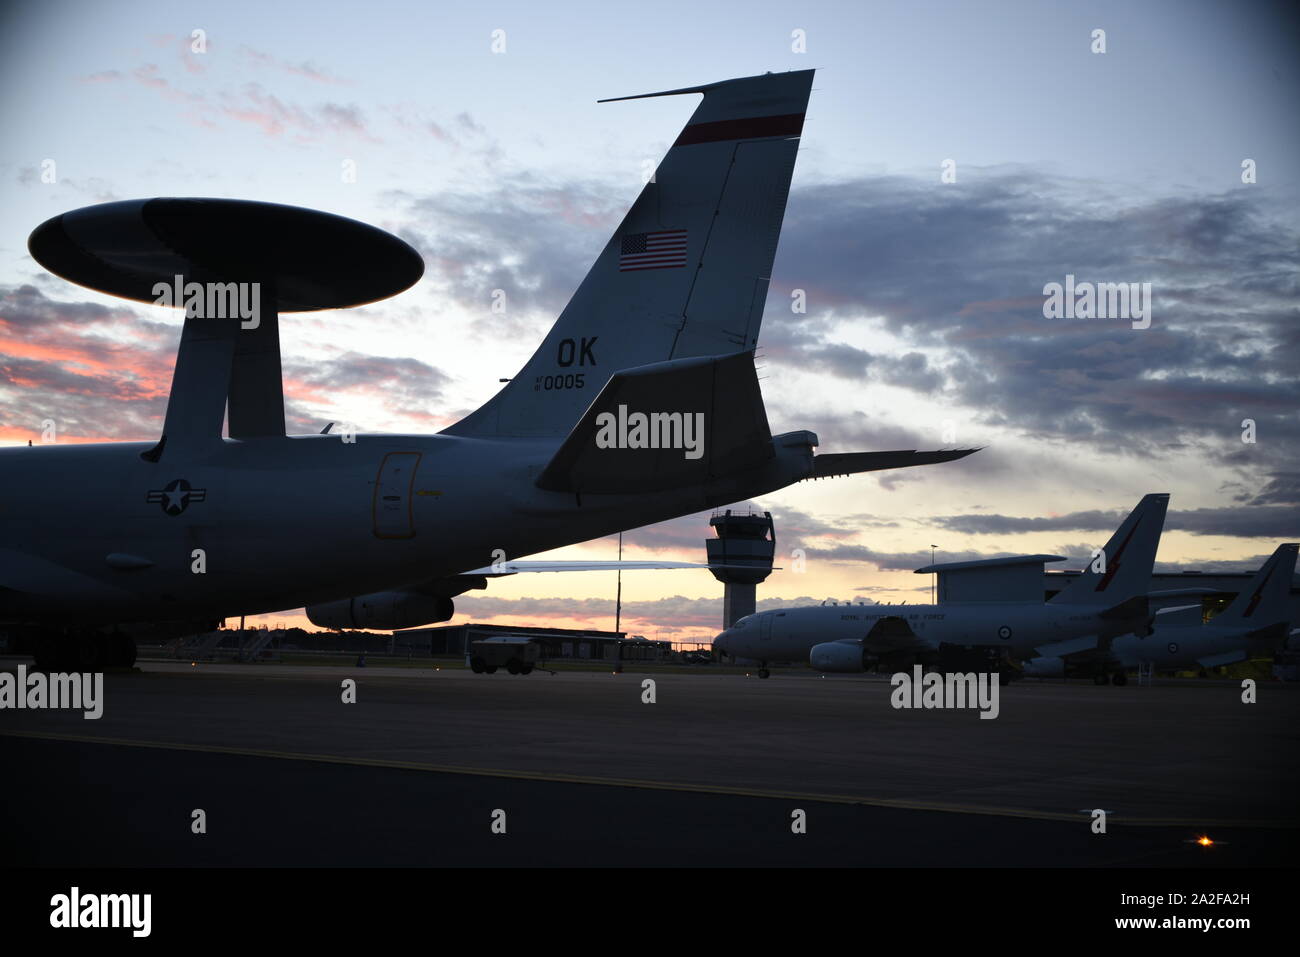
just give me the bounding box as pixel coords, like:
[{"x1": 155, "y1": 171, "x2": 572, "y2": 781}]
[{"x1": 1024, "y1": 544, "x2": 1300, "y2": 683}]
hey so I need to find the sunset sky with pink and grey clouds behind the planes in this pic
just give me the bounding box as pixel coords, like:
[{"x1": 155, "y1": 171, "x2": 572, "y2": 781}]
[{"x1": 0, "y1": 0, "x2": 1300, "y2": 640}]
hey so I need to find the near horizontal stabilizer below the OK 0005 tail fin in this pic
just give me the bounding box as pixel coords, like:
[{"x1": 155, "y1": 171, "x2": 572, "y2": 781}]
[{"x1": 537, "y1": 351, "x2": 775, "y2": 494}]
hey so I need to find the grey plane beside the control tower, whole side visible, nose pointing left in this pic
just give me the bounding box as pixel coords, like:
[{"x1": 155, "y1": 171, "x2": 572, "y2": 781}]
[{"x1": 714, "y1": 494, "x2": 1174, "y2": 684}]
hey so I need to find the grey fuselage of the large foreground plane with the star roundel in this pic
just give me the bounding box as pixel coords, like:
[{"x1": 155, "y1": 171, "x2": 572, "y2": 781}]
[{"x1": 0, "y1": 434, "x2": 813, "y2": 624}]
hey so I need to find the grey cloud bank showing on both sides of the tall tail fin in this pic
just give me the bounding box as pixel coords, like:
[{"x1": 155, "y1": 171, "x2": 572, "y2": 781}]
[{"x1": 382, "y1": 169, "x2": 1300, "y2": 520}]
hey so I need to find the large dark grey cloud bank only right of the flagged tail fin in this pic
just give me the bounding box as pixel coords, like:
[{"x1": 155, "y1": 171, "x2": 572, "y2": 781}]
[{"x1": 762, "y1": 170, "x2": 1300, "y2": 468}]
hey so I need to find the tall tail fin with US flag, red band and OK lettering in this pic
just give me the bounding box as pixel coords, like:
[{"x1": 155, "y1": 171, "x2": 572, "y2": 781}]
[{"x1": 446, "y1": 70, "x2": 813, "y2": 437}]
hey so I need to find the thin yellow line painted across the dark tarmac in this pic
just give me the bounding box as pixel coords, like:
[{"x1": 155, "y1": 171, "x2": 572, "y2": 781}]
[{"x1": 0, "y1": 731, "x2": 1279, "y2": 830}]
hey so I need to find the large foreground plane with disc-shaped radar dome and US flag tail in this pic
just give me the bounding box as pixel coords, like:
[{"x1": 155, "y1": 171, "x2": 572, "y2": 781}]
[{"x1": 0, "y1": 70, "x2": 971, "y2": 667}]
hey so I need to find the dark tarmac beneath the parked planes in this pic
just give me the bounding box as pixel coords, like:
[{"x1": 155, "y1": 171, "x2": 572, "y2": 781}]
[{"x1": 0, "y1": 659, "x2": 1300, "y2": 867}]
